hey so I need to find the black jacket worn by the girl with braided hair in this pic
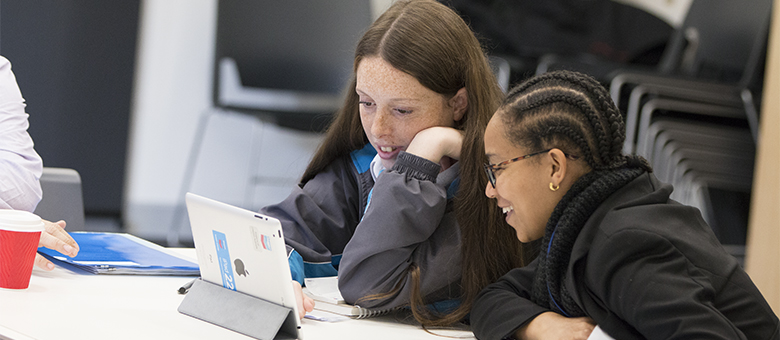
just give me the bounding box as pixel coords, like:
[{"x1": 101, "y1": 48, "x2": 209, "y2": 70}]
[{"x1": 471, "y1": 174, "x2": 780, "y2": 340}]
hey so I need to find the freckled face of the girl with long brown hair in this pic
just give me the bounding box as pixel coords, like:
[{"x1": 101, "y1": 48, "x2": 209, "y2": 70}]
[{"x1": 355, "y1": 57, "x2": 455, "y2": 169}]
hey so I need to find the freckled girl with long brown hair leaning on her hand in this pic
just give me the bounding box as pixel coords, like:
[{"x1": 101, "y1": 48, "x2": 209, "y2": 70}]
[{"x1": 262, "y1": 0, "x2": 522, "y2": 324}]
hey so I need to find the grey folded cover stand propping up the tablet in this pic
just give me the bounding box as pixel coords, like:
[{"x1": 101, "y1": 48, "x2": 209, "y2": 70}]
[{"x1": 178, "y1": 279, "x2": 297, "y2": 340}]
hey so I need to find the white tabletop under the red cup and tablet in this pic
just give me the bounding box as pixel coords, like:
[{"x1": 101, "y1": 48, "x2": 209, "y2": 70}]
[{"x1": 0, "y1": 249, "x2": 473, "y2": 340}]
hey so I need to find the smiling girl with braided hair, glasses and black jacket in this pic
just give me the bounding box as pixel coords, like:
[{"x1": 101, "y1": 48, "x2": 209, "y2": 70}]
[{"x1": 471, "y1": 71, "x2": 780, "y2": 339}]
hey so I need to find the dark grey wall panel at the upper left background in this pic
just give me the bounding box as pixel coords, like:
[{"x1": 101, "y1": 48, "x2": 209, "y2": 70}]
[{"x1": 0, "y1": 0, "x2": 139, "y2": 216}]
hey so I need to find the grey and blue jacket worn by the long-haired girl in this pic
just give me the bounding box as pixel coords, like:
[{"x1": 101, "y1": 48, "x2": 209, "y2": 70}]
[{"x1": 262, "y1": 144, "x2": 460, "y2": 308}]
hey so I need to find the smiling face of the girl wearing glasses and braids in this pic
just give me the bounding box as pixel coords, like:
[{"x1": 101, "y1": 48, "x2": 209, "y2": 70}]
[{"x1": 485, "y1": 112, "x2": 556, "y2": 242}]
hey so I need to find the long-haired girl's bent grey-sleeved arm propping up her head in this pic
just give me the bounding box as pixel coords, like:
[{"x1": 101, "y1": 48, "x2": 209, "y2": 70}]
[{"x1": 339, "y1": 152, "x2": 461, "y2": 308}]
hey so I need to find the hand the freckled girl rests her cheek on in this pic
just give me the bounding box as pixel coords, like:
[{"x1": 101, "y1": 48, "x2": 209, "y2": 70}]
[{"x1": 406, "y1": 126, "x2": 463, "y2": 165}]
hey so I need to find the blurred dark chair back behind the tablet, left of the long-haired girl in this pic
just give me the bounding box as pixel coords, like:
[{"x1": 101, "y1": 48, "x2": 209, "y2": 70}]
[{"x1": 213, "y1": 0, "x2": 371, "y2": 131}]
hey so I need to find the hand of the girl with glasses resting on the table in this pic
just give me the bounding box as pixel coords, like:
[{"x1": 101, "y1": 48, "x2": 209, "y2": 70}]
[{"x1": 515, "y1": 312, "x2": 596, "y2": 340}]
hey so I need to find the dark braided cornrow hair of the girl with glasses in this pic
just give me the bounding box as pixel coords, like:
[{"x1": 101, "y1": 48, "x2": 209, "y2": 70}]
[{"x1": 499, "y1": 71, "x2": 652, "y2": 172}]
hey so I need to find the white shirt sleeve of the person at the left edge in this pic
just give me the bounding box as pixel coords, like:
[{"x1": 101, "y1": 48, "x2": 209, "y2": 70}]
[{"x1": 0, "y1": 56, "x2": 43, "y2": 211}]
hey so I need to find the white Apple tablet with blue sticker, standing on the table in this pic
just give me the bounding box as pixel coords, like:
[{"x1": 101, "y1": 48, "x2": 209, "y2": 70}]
[{"x1": 185, "y1": 193, "x2": 302, "y2": 338}]
